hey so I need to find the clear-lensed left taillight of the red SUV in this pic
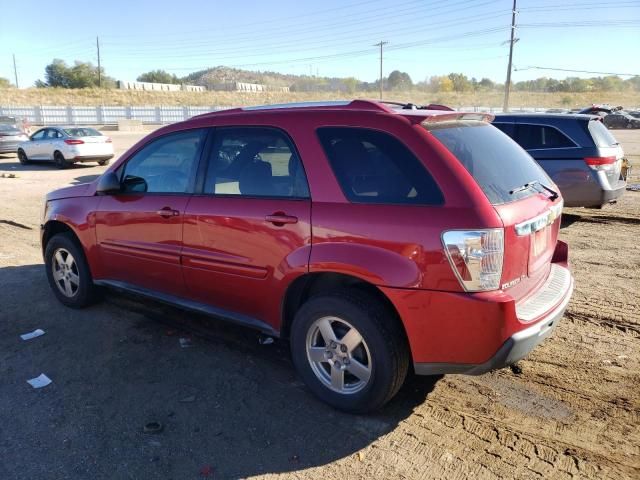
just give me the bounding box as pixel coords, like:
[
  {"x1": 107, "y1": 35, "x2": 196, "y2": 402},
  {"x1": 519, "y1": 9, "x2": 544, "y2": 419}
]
[{"x1": 442, "y1": 228, "x2": 504, "y2": 292}]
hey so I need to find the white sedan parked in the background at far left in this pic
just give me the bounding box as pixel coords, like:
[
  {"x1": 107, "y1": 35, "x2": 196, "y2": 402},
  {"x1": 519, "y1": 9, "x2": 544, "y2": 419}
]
[{"x1": 18, "y1": 127, "x2": 113, "y2": 168}]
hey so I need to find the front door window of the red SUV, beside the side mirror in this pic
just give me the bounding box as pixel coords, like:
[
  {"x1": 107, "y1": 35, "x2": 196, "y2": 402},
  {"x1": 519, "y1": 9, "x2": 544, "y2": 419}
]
[{"x1": 122, "y1": 130, "x2": 205, "y2": 193}]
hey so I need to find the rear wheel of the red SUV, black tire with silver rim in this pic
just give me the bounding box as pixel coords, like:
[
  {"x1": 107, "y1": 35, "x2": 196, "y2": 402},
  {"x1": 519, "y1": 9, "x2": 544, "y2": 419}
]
[{"x1": 291, "y1": 290, "x2": 410, "y2": 413}]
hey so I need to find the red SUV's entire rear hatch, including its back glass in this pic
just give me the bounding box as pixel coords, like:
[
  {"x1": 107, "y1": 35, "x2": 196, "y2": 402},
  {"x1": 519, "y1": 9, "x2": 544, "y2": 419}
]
[{"x1": 423, "y1": 124, "x2": 562, "y2": 301}]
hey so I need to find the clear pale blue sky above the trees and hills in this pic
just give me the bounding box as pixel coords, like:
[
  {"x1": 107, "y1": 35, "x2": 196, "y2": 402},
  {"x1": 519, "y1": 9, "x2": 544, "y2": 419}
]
[{"x1": 0, "y1": 0, "x2": 640, "y2": 87}]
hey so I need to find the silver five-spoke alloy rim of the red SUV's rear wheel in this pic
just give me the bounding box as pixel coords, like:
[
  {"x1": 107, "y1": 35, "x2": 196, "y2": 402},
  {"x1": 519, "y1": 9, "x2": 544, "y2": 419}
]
[{"x1": 306, "y1": 316, "x2": 373, "y2": 394}]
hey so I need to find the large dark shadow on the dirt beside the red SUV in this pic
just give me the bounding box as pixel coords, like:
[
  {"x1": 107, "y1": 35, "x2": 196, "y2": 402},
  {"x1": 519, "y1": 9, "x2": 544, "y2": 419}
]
[{"x1": 0, "y1": 264, "x2": 438, "y2": 478}]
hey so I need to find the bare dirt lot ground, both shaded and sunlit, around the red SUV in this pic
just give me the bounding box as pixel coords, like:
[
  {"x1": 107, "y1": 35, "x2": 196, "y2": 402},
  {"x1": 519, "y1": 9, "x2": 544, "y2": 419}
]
[{"x1": 0, "y1": 131, "x2": 640, "y2": 480}]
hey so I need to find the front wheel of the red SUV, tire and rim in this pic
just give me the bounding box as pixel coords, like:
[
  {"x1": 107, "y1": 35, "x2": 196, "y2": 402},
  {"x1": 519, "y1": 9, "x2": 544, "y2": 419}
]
[{"x1": 44, "y1": 233, "x2": 97, "y2": 308}]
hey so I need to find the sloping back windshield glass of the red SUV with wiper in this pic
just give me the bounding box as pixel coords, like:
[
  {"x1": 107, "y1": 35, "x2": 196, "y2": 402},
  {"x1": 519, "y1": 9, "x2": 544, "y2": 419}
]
[{"x1": 423, "y1": 121, "x2": 552, "y2": 205}]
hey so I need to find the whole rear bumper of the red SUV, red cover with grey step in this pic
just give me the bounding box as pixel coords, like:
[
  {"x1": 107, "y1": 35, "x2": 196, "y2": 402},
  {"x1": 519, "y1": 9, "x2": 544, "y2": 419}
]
[{"x1": 379, "y1": 251, "x2": 574, "y2": 375}]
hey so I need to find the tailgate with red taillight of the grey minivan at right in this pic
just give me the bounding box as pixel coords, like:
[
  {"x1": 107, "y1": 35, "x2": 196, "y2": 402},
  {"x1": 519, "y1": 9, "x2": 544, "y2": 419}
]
[{"x1": 585, "y1": 118, "x2": 624, "y2": 190}]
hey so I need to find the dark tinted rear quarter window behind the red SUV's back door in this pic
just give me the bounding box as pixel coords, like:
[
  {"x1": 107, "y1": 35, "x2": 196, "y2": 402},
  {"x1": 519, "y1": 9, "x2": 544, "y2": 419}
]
[{"x1": 318, "y1": 127, "x2": 443, "y2": 205}]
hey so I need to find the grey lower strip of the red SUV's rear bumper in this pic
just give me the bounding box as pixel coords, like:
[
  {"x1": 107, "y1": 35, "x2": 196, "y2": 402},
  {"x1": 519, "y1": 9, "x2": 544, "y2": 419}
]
[{"x1": 413, "y1": 281, "x2": 573, "y2": 375}]
